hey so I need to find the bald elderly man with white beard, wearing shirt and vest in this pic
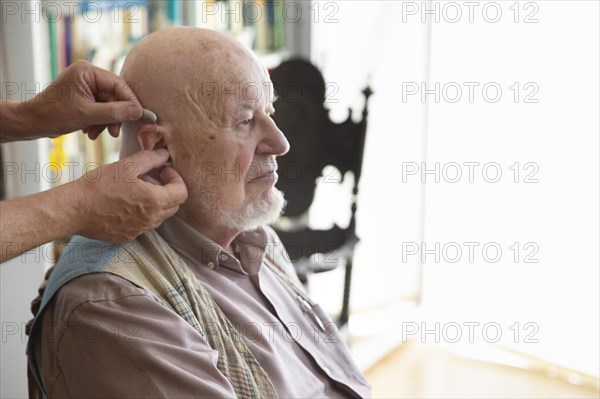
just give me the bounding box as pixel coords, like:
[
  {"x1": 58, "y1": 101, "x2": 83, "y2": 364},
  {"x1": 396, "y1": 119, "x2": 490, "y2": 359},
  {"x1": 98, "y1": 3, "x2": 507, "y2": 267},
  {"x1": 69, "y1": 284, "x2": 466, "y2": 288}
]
[{"x1": 28, "y1": 28, "x2": 370, "y2": 398}]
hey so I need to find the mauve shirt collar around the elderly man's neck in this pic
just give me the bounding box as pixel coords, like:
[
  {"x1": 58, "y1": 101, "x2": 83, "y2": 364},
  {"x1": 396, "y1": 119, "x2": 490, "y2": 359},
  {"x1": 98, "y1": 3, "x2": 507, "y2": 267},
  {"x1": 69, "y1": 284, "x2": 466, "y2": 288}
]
[{"x1": 156, "y1": 216, "x2": 267, "y2": 275}]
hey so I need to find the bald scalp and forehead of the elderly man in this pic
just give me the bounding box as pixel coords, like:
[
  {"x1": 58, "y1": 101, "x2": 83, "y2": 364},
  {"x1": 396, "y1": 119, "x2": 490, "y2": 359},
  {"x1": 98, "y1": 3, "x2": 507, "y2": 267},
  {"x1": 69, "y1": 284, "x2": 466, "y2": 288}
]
[{"x1": 121, "y1": 27, "x2": 268, "y2": 156}]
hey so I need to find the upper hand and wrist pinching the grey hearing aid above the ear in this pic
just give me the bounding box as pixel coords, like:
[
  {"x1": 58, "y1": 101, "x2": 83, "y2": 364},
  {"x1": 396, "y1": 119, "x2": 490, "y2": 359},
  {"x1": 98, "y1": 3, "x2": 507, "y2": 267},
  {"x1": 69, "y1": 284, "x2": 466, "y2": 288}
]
[{"x1": 0, "y1": 61, "x2": 142, "y2": 142}]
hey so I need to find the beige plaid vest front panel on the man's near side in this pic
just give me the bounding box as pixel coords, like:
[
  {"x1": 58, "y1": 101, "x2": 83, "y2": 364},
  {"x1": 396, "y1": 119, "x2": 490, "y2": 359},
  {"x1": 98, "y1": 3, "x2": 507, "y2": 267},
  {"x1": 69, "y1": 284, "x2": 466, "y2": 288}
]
[{"x1": 105, "y1": 231, "x2": 277, "y2": 398}]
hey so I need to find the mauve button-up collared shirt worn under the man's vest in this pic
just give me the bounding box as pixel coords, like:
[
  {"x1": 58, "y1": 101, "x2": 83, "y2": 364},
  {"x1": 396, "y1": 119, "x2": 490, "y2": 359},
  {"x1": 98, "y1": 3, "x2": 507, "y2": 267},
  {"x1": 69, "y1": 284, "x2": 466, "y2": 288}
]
[{"x1": 34, "y1": 217, "x2": 370, "y2": 398}]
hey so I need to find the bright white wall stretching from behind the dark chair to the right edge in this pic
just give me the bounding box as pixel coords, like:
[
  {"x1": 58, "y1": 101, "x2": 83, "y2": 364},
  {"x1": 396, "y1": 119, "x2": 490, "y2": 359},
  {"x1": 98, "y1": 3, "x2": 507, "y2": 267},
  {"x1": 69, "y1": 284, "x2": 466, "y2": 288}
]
[{"x1": 313, "y1": 1, "x2": 600, "y2": 375}]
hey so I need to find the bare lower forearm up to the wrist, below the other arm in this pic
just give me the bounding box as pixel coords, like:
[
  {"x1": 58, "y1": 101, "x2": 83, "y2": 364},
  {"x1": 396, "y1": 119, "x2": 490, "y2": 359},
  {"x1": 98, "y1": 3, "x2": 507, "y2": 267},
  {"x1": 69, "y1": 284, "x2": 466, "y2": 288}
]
[{"x1": 0, "y1": 183, "x2": 80, "y2": 263}]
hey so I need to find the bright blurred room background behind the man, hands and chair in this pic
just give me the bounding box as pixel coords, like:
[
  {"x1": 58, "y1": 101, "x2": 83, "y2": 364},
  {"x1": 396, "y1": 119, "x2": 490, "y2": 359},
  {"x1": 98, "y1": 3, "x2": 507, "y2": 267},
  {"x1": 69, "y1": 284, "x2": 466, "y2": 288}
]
[{"x1": 0, "y1": 0, "x2": 600, "y2": 398}]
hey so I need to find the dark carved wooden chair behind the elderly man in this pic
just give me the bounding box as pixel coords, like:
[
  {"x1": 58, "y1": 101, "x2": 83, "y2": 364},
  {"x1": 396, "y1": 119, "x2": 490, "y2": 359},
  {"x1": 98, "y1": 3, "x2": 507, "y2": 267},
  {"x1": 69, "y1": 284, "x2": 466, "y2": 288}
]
[{"x1": 271, "y1": 59, "x2": 372, "y2": 327}]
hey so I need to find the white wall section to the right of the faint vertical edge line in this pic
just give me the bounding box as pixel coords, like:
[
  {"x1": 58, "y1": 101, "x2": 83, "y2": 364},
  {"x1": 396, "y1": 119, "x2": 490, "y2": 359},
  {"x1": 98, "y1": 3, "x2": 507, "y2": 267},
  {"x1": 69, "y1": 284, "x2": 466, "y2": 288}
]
[{"x1": 422, "y1": 1, "x2": 600, "y2": 376}]
